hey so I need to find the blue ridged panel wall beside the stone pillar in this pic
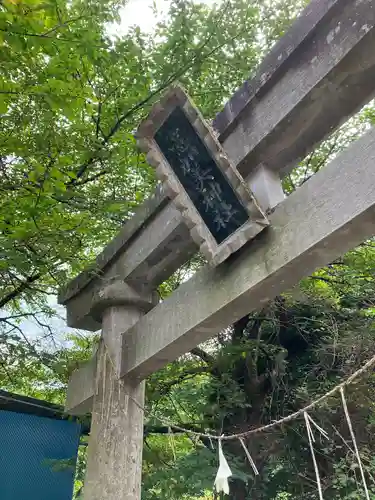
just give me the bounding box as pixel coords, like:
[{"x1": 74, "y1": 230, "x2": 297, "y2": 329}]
[{"x1": 0, "y1": 411, "x2": 81, "y2": 500}]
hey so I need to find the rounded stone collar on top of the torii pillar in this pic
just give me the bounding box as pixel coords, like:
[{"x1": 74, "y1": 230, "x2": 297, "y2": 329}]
[{"x1": 90, "y1": 279, "x2": 159, "y2": 322}]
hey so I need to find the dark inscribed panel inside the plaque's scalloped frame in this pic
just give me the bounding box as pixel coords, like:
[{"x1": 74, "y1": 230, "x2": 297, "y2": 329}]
[{"x1": 155, "y1": 107, "x2": 249, "y2": 244}]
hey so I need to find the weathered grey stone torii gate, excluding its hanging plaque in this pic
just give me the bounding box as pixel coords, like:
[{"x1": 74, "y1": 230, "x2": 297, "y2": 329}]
[{"x1": 59, "y1": 0, "x2": 375, "y2": 500}]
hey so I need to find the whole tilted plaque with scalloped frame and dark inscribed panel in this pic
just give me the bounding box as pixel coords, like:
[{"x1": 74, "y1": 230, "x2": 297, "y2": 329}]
[{"x1": 135, "y1": 86, "x2": 269, "y2": 266}]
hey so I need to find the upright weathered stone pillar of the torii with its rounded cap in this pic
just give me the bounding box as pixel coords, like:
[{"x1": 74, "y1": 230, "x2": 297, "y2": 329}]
[{"x1": 84, "y1": 280, "x2": 155, "y2": 500}]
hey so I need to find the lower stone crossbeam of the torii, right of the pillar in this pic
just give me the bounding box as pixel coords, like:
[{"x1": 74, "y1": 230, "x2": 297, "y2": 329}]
[{"x1": 121, "y1": 129, "x2": 375, "y2": 379}]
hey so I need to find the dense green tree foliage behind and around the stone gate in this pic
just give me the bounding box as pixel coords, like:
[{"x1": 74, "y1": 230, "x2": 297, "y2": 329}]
[{"x1": 0, "y1": 0, "x2": 375, "y2": 500}]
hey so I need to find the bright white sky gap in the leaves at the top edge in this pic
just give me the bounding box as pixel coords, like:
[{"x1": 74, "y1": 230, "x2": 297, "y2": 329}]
[{"x1": 108, "y1": 0, "x2": 217, "y2": 36}]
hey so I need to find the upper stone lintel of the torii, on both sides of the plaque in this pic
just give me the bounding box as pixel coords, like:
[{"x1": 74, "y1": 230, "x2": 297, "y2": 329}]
[{"x1": 60, "y1": 0, "x2": 375, "y2": 330}]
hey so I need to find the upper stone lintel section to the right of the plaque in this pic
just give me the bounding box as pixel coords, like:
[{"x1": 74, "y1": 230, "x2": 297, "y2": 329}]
[{"x1": 214, "y1": 0, "x2": 375, "y2": 178}]
